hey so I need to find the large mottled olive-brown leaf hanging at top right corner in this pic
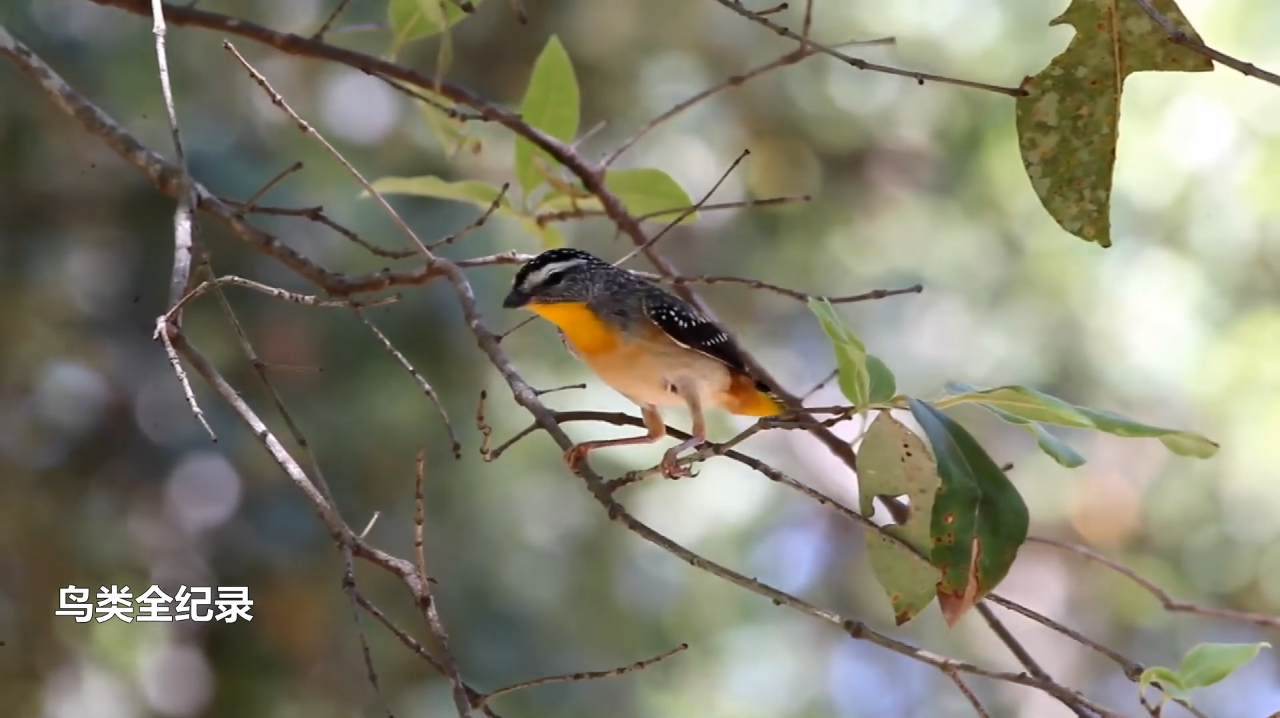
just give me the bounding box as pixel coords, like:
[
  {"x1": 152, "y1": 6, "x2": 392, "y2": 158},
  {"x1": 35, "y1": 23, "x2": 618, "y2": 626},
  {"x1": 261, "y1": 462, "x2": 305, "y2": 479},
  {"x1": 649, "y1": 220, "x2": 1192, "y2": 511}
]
[{"x1": 1016, "y1": 0, "x2": 1213, "y2": 247}]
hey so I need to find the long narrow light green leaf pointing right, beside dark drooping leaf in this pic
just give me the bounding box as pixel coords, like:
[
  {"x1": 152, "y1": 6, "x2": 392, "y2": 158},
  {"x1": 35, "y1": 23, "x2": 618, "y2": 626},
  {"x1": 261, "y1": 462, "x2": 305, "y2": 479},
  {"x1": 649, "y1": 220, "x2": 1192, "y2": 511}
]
[{"x1": 937, "y1": 381, "x2": 1219, "y2": 458}]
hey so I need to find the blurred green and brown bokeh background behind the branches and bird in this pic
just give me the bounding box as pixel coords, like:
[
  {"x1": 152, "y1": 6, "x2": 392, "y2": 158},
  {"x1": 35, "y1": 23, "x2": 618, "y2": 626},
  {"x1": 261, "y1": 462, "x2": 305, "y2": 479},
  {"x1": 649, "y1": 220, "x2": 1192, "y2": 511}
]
[{"x1": 0, "y1": 0, "x2": 1280, "y2": 718}]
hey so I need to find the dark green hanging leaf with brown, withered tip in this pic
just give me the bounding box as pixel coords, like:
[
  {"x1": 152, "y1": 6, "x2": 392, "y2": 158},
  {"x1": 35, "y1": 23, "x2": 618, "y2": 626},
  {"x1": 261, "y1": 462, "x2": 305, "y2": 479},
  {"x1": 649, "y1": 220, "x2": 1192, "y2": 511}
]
[{"x1": 906, "y1": 397, "x2": 1030, "y2": 626}]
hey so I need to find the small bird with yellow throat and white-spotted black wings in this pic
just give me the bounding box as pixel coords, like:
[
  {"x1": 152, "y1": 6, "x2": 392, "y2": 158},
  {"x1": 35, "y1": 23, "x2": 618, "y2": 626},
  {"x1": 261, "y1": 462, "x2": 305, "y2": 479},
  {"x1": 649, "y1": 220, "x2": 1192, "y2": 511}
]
[{"x1": 502, "y1": 247, "x2": 786, "y2": 479}]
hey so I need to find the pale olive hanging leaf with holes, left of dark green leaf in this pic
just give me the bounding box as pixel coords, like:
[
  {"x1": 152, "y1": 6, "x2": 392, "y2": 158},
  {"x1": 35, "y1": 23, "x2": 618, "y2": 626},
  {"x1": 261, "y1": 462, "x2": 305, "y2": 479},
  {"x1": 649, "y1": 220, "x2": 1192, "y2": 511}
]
[{"x1": 858, "y1": 411, "x2": 940, "y2": 626}]
